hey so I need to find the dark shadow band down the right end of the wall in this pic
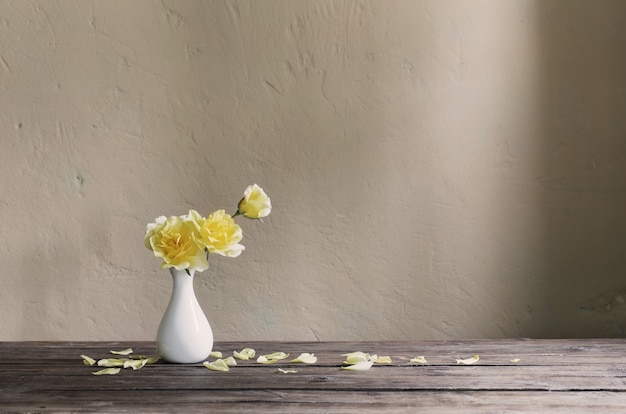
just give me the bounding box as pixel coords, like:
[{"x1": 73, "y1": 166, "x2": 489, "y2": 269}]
[{"x1": 535, "y1": 0, "x2": 626, "y2": 337}]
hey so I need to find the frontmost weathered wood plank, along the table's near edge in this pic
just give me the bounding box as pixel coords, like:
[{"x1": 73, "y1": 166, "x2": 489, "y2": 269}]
[{"x1": 1, "y1": 390, "x2": 626, "y2": 413}]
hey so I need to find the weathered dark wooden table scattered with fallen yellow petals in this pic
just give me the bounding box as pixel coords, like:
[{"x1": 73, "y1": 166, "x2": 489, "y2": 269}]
[{"x1": 0, "y1": 339, "x2": 626, "y2": 413}]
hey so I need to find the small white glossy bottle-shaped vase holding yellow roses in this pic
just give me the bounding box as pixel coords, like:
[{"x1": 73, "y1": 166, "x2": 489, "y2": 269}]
[{"x1": 156, "y1": 268, "x2": 213, "y2": 363}]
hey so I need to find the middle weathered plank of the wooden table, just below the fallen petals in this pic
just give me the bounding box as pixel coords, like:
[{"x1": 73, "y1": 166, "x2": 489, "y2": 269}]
[{"x1": 0, "y1": 366, "x2": 626, "y2": 392}]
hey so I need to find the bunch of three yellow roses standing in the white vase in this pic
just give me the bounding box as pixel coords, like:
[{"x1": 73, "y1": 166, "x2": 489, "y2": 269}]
[{"x1": 144, "y1": 184, "x2": 272, "y2": 273}]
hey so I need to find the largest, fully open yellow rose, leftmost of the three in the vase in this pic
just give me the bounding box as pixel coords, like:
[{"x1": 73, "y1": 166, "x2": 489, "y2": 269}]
[{"x1": 144, "y1": 216, "x2": 209, "y2": 272}]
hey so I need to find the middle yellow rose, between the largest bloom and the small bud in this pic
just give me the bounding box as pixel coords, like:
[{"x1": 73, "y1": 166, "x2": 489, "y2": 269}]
[{"x1": 189, "y1": 210, "x2": 245, "y2": 257}]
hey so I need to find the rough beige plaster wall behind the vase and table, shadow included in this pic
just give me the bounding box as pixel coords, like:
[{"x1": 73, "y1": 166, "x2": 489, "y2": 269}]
[{"x1": 0, "y1": 0, "x2": 626, "y2": 341}]
